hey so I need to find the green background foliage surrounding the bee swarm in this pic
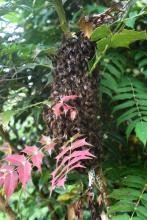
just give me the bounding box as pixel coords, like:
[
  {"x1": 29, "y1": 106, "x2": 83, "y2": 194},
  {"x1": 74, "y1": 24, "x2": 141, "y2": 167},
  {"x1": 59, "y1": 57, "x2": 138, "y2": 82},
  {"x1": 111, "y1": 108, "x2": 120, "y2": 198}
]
[{"x1": 0, "y1": 0, "x2": 147, "y2": 220}]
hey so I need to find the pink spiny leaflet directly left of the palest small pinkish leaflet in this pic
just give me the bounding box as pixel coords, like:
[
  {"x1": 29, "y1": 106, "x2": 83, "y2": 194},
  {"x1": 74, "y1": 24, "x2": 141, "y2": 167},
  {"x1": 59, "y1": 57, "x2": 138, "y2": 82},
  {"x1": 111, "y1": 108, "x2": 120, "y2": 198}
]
[{"x1": 22, "y1": 146, "x2": 44, "y2": 172}]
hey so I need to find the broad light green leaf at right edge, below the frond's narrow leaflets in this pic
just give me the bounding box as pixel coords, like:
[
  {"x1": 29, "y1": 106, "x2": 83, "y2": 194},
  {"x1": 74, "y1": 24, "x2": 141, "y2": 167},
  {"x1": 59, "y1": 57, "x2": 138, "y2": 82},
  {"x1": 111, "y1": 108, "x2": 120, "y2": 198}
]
[{"x1": 135, "y1": 121, "x2": 147, "y2": 146}]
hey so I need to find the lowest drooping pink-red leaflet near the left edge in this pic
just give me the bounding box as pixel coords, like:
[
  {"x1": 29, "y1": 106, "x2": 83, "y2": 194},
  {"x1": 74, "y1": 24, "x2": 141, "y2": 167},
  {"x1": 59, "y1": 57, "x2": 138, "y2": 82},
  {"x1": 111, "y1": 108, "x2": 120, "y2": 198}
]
[{"x1": 4, "y1": 171, "x2": 18, "y2": 198}]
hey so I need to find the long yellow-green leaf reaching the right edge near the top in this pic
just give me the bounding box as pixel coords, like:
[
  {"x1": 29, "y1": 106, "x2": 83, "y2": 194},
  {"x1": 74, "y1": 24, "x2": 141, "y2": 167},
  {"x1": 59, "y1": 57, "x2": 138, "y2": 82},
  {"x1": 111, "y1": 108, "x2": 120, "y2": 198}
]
[{"x1": 110, "y1": 29, "x2": 147, "y2": 48}]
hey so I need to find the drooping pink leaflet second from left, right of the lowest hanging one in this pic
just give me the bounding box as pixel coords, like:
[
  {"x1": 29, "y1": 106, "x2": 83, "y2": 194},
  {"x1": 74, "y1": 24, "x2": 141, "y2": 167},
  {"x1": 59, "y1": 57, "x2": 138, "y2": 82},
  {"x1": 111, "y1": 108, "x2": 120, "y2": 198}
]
[{"x1": 17, "y1": 161, "x2": 32, "y2": 188}]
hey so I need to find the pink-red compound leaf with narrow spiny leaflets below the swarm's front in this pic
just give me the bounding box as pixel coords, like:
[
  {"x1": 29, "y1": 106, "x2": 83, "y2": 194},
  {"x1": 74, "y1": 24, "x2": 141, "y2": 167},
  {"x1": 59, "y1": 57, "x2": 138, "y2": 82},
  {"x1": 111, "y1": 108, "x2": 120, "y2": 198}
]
[{"x1": 50, "y1": 136, "x2": 95, "y2": 193}]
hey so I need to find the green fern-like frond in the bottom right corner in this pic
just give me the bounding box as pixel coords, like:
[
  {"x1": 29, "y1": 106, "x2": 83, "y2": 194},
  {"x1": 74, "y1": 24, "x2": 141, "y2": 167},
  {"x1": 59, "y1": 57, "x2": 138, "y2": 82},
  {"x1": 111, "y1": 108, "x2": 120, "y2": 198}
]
[{"x1": 109, "y1": 175, "x2": 147, "y2": 220}]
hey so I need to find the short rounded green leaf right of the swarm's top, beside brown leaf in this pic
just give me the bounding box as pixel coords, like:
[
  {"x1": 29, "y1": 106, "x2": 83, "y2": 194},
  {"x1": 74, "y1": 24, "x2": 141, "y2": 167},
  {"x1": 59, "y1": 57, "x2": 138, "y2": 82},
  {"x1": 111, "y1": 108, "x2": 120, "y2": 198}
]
[{"x1": 91, "y1": 24, "x2": 111, "y2": 41}]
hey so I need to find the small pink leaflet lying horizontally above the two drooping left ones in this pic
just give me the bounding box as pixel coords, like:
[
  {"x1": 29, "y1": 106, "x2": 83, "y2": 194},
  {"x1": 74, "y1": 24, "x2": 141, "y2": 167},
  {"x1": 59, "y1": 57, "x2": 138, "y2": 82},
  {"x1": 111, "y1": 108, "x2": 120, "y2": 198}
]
[{"x1": 5, "y1": 154, "x2": 26, "y2": 166}]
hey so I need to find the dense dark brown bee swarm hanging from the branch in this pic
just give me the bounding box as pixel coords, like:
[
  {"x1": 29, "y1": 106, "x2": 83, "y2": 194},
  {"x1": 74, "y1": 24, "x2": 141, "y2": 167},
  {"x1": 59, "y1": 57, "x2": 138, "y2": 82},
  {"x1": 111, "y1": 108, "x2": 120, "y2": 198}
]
[{"x1": 44, "y1": 3, "x2": 121, "y2": 167}]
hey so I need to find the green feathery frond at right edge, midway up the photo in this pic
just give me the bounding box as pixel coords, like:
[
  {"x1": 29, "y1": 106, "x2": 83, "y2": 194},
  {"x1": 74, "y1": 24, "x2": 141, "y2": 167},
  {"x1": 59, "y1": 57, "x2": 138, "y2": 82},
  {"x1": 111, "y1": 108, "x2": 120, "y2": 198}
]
[{"x1": 112, "y1": 78, "x2": 147, "y2": 144}]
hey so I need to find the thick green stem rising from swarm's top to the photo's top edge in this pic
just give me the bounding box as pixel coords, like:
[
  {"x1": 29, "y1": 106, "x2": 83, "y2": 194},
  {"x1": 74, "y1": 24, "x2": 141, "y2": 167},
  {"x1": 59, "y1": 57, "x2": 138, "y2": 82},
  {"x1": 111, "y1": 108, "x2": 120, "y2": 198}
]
[{"x1": 52, "y1": 0, "x2": 70, "y2": 36}]
